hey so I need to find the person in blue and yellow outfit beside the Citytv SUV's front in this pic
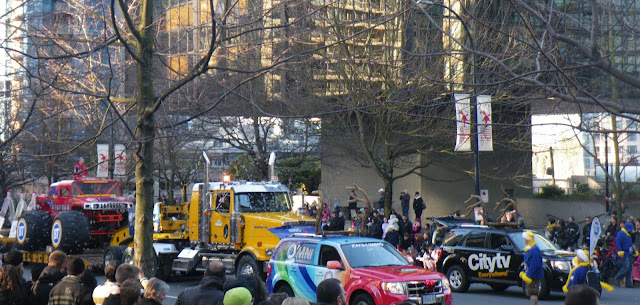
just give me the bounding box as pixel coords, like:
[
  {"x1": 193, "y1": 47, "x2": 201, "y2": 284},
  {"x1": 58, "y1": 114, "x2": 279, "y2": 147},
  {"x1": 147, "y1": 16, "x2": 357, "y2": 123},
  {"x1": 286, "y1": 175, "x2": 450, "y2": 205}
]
[{"x1": 520, "y1": 231, "x2": 544, "y2": 305}]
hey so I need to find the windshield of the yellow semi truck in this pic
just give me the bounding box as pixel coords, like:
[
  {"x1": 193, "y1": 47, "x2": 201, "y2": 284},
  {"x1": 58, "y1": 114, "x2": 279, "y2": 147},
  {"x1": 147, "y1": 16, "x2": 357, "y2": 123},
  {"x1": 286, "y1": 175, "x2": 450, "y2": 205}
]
[{"x1": 235, "y1": 192, "x2": 291, "y2": 213}]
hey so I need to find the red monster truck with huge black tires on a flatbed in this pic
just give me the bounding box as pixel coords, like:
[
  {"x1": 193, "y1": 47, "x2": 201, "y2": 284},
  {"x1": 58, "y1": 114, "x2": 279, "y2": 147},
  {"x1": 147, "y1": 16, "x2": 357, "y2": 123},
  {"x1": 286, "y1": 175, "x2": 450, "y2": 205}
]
[{"x1": 16, "y1": 177, "x2": 133, "y2": 253}]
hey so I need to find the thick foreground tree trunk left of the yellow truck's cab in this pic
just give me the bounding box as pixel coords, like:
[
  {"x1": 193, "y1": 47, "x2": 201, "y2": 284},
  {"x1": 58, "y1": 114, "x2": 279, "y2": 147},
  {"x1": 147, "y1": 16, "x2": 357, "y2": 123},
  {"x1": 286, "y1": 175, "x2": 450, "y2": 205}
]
[{"x1": 134, "y1": 0, "x2": 155, "y2": 275}]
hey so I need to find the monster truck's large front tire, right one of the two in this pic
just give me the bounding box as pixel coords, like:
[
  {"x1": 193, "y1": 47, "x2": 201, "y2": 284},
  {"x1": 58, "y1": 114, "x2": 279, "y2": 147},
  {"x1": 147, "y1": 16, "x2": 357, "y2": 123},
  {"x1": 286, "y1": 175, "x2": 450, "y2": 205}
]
[{"x1": 51, "y1": 211, "x2": 90, "y2": 254}]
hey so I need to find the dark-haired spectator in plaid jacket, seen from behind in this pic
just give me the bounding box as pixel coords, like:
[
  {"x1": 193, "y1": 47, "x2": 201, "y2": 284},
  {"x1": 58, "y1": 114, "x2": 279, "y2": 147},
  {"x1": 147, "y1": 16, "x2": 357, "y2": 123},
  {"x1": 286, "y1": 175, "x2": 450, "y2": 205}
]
[{"x1": 49, "y1": 257, "x2": 93, "y2": 305}]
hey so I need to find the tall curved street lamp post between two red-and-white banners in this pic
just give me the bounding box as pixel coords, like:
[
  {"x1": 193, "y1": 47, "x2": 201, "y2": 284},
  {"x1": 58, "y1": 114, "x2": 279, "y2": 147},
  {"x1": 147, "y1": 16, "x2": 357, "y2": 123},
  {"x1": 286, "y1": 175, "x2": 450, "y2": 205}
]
[{"x1": 416, "y1": 0, "x2": 480, "y2": 196}]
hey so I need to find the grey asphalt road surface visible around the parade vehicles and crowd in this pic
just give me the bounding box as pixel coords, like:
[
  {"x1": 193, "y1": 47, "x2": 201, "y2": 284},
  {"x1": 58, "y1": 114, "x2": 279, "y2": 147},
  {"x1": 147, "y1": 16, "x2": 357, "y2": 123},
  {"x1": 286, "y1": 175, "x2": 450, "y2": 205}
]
[{"x1": 24, "y1": 266, "x2": 640, "y2": 305}]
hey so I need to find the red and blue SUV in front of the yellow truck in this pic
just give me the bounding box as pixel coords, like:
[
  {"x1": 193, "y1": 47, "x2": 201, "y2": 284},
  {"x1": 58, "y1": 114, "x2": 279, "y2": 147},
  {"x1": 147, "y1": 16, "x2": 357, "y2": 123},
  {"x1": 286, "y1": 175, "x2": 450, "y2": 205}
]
[{"x1": 267, "y1": 234, "x2": 451, "y2": 305}]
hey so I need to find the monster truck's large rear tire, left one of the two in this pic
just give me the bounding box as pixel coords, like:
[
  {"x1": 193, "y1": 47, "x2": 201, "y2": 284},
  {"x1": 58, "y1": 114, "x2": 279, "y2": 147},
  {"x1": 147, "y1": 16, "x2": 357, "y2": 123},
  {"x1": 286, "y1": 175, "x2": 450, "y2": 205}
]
[{"x1": 16, "y1": 211, "x2": 52, "y2": 251}]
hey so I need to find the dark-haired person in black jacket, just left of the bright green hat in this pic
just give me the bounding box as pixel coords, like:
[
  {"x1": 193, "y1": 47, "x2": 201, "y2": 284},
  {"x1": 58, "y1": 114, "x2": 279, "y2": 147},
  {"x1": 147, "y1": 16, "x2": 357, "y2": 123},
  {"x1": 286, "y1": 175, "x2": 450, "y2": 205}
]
[{"x1": 176, "y1": 262, "x2": 225, "y2": 305}]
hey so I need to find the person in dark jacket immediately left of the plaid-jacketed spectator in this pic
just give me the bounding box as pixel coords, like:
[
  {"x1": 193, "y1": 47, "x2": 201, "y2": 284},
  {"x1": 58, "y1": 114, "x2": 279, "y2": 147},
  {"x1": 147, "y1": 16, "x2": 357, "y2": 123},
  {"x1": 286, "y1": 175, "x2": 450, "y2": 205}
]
[{"x1": 31, "y1": 250, "x2": 67, "y2": 305}]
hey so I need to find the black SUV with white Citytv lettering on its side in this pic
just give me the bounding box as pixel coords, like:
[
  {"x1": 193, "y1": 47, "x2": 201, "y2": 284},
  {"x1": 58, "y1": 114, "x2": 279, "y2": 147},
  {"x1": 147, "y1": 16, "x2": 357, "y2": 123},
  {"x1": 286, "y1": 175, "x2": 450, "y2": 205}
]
[{"x1": 436, "y1": 225, "x2": 575, "y2": 298}]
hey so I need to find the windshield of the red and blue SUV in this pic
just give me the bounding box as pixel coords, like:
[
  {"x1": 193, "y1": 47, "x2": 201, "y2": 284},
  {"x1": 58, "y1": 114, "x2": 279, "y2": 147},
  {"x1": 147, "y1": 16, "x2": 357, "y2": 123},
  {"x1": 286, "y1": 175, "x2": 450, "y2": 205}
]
[{"x1": 341, "y1": 241, "x2": 409, "y2": 268}]
